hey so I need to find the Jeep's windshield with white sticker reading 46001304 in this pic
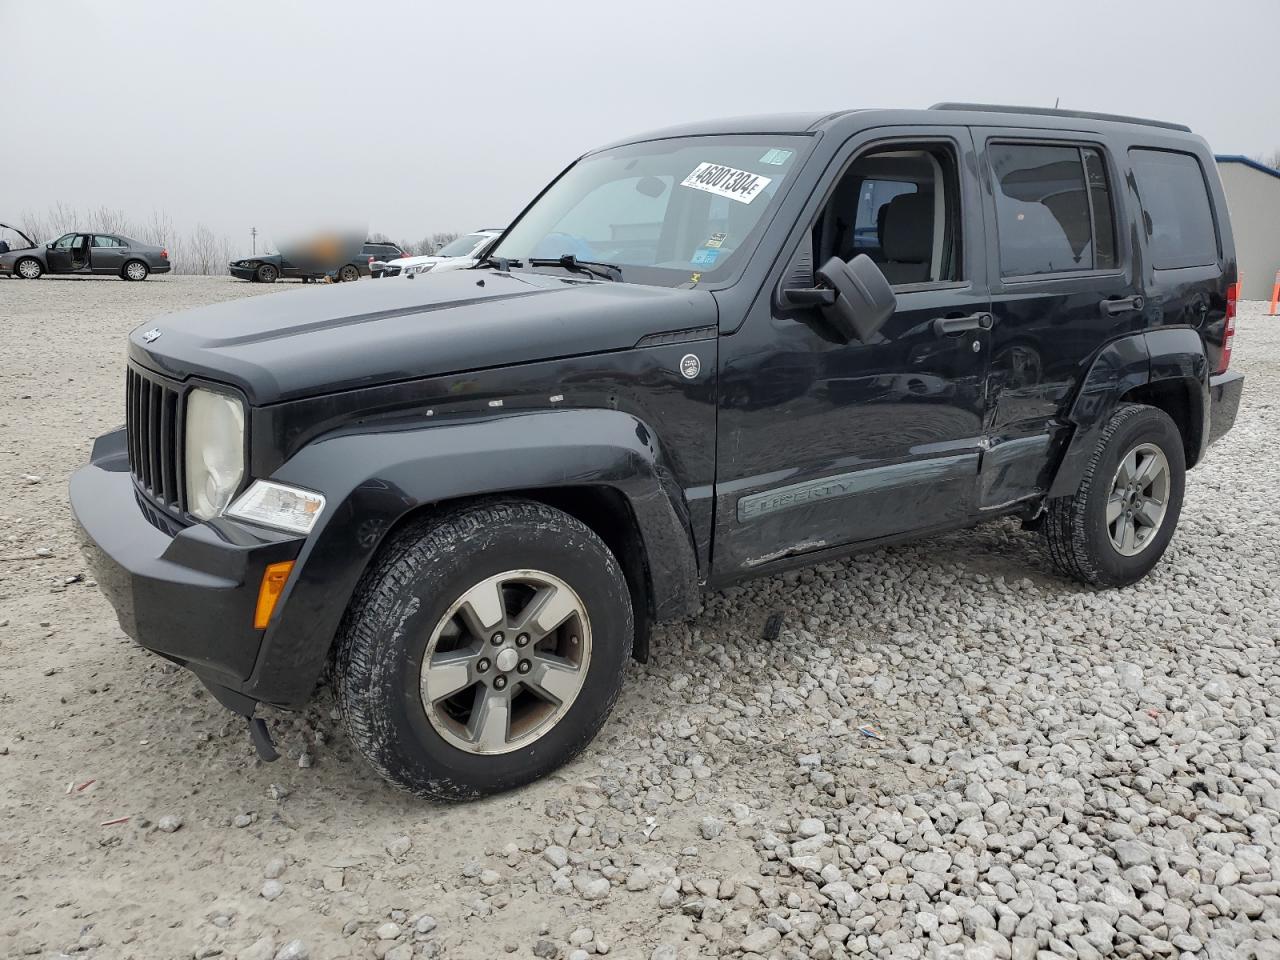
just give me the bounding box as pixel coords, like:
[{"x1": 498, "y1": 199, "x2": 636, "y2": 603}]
[{"x1": 490, "y1": 134, "x2": 809, "y2": 287}]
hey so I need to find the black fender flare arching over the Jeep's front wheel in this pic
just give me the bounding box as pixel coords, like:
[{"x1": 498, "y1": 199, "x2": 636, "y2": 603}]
[{"x1": 247, "y1": 410, "x2": 700, "y2": 705}]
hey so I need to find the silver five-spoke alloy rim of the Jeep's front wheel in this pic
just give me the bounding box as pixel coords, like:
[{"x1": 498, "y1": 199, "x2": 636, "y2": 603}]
[{"x1": 419, "y1": 570, "x2": 591, "y2": 754}]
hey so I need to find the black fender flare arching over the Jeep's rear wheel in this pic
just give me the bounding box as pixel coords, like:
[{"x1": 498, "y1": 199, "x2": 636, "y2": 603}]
[{"x1": 1048, "y1": 328, "x2": 1210, "y2": 498}]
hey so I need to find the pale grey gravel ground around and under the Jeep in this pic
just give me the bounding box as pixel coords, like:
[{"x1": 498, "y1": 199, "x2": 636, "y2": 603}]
[{"x1": 0, "y1": 278, "x2": 1280, "y2": 960}]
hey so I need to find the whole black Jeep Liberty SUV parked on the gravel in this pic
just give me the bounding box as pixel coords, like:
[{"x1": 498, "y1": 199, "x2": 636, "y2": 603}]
[{"x1": 70, "y1": 105, "x2": 1242, "y2": 799}]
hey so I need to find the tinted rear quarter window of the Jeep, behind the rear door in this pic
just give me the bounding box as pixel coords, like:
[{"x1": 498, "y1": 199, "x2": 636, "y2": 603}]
[{"x1": 1129, "y1": 148, "x2": 1219, "y2": 270}]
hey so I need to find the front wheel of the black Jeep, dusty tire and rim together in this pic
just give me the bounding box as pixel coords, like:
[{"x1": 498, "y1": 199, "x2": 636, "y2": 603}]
[{"x1": 334, "y1": 500, "x2": 632, "y2": 801}]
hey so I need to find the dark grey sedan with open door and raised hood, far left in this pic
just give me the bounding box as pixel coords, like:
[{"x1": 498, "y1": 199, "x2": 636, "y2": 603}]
[{"x1": 0, "y1": 224, "x2": 170, "y2": 280}]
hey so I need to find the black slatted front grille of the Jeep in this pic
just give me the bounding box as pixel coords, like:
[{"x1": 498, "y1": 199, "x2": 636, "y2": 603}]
[{"x1": 124, "y1": 366, "x2": 187, "y2": 513}]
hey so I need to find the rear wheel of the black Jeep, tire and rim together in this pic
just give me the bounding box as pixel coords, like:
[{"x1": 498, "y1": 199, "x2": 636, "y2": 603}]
[{"x1": 1043, "y1": 403, "x2": 1187, "y2": 586}]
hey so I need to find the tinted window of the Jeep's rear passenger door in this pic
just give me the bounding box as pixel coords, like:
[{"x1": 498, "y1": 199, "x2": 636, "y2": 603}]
[{"x1": 987, "y1": 143, "x2": 1116, "y2": 276}]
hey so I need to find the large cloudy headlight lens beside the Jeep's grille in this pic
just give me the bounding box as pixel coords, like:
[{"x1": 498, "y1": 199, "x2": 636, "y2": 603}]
[{"x1": 186, "y1": 388, "x2": 244, "y2": 520}]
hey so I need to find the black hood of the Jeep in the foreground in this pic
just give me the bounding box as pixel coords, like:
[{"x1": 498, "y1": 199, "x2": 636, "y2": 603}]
[{"x1": 129, "y1": 270, "x2": 717, "y2": 404}]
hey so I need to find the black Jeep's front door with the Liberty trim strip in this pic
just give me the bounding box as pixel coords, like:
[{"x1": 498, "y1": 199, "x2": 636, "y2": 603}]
[{"x1": 713, "y1": 127, "x2": 991, "y2": 579}]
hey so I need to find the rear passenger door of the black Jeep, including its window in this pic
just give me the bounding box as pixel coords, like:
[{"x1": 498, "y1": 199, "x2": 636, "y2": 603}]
[{"x1": 974, "y1": 128, "x2": 1143, "y2": 509}]
